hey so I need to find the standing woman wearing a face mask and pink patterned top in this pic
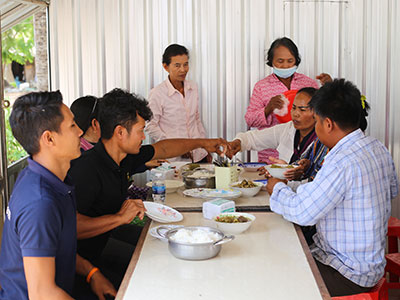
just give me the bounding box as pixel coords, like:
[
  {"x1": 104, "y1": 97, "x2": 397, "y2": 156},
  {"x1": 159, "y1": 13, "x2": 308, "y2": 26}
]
[{"x1": 245, "y1": 37, "x2": 332, "y2": 163}]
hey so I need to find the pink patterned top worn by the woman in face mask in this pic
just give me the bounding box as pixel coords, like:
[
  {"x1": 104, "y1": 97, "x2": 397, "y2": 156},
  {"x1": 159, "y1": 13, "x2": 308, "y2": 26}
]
[{"x1": 244, "y1": 73, "x2": 318, "y2": 163}]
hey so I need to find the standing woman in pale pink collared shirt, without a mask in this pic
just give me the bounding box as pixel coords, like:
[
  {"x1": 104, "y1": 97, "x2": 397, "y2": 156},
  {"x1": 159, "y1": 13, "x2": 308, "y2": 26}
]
[{"x1": 146, "y1": 44, "x2": 208, "y2": 162}]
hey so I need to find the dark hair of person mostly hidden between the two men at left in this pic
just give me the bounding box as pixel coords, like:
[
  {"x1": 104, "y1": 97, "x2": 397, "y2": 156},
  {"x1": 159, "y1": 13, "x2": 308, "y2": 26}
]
[{"x1": 71, "y1": 96, "x2": 99, "y2": 133}]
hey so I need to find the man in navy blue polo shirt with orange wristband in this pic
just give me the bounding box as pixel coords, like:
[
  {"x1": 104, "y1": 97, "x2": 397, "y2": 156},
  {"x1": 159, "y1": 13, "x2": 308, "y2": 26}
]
[{"x1": 0, "y1": 92, "x2": 115, "y2": 300}]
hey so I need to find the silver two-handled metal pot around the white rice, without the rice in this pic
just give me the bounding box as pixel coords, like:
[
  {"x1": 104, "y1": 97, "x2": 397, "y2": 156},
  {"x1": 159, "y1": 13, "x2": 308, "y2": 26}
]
[{"x1": 157, "y1": 226, "x2": 235, "y2": 260}]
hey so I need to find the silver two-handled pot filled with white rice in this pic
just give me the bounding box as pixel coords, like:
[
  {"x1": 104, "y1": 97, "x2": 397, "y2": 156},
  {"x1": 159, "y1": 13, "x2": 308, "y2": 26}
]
[{"x1": 157, "y1": 226, "x2": 235, "y2": 260}]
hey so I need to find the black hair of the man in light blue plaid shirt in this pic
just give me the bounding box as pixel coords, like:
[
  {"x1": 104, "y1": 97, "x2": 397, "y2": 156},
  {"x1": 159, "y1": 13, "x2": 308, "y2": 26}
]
[{"x1": 310, "y1": 79, "x2": 369, "y2": 131}]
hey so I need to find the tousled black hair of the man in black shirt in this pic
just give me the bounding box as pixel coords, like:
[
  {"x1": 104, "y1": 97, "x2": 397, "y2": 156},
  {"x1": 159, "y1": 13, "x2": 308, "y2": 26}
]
[{"x1": 98, "y1": 88, "x2": 153, "y2": 140}]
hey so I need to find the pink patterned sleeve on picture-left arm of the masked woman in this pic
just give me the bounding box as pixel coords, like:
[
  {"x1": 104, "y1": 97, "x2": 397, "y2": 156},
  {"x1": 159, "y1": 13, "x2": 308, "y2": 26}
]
[{"x1": 244, "y1": 83, "x2": 273, "y2": 128}]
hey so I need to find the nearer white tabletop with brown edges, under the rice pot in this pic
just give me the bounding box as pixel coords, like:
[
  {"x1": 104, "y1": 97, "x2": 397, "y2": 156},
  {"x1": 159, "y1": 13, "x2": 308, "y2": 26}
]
[{"x1": 116, "y1": 211, "x2": 331, "y2": 300}]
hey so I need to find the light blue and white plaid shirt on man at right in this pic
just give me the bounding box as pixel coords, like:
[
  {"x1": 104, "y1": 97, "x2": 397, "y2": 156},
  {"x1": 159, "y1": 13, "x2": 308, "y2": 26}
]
[{"x1": 270, "y1": 129, "x2": 399, "y2": 287}]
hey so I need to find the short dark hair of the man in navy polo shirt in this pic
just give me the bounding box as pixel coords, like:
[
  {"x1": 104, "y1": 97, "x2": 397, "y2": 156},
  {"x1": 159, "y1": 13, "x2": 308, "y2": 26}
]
[{"x1": 9, "y1": 91, "x2": 64, "y2": 155}]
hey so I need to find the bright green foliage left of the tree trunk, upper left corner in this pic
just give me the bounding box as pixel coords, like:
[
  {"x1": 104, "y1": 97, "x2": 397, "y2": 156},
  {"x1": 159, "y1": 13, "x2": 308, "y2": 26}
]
[{"x1": 2, "y1": 17, "x2": 35, "y2": 65}]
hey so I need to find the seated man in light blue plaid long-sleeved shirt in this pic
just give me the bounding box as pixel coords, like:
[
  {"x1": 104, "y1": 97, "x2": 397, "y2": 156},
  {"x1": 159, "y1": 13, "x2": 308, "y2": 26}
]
[{"x1": 267, "y1": 79, "x2": 399, "y2": 296}]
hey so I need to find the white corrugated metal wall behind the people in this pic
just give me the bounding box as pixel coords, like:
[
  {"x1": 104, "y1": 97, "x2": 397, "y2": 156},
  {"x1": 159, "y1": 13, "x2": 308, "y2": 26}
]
[{"x1": 50, "y1": 0, "x2": 400, "y2": 215}]
